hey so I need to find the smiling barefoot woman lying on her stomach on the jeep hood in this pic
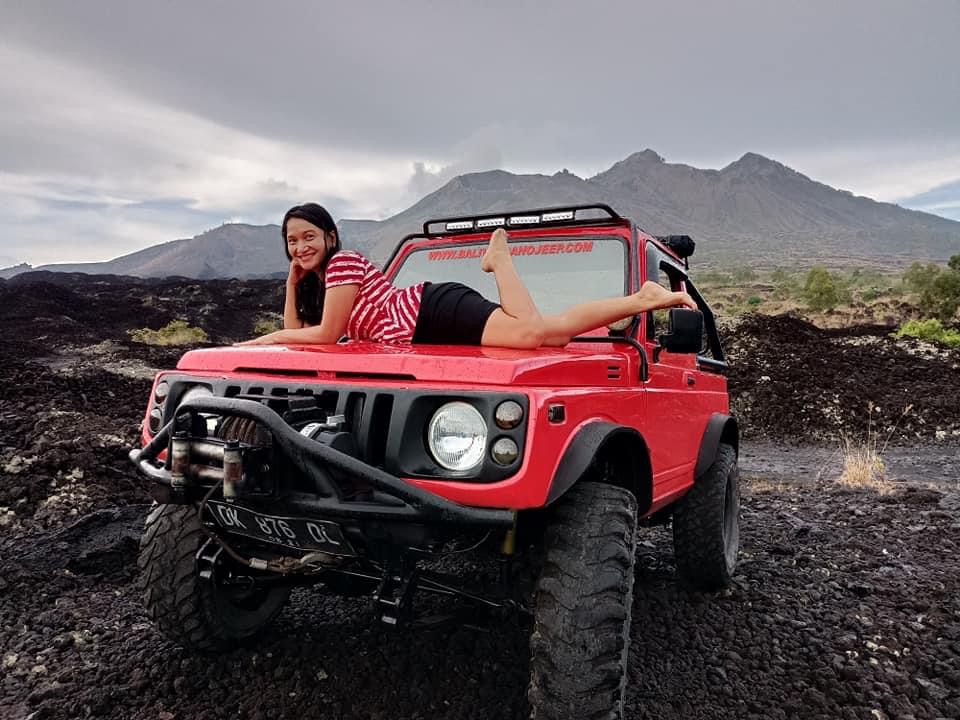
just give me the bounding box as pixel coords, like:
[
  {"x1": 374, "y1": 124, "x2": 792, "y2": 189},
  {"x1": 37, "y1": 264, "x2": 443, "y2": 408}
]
[{"x1": 240, "y1": 203, "x2": 697, "y2": 348}]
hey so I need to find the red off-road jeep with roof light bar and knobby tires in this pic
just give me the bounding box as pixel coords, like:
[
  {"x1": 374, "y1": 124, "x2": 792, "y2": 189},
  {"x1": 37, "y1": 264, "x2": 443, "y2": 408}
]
[{"x1": 130, "y1": 205, "x2": 739, "y2": 718}]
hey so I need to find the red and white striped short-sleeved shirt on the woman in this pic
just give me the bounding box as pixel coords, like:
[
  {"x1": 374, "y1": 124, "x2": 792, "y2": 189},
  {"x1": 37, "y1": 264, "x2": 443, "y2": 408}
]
[{"x1": 324, "y1": 250, "x2": 424, "y2": 344}]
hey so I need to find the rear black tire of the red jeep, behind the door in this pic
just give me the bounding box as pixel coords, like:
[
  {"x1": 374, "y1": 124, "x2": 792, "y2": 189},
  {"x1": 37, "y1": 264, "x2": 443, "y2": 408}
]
[{"x1": 673, "y1": 443, "x2": 740, "y2": 592}]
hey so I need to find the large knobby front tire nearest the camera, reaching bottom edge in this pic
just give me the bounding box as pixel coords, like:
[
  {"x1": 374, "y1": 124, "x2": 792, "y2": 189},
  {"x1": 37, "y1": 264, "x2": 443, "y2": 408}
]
[{"x1": 527, "y1": 483, "x2": 637, "y2": 720}]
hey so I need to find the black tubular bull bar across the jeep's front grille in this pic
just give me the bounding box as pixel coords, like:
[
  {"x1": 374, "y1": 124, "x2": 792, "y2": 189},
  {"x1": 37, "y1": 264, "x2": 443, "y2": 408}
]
[{"x1": 129, "y1": 397, "x2": 514, "y2": 527}]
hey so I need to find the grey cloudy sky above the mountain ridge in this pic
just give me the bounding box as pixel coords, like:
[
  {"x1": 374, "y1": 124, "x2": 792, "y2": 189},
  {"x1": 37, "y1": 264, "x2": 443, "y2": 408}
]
[{"x1": 0, "y1": 0, "x2": 960, "y2": 266}]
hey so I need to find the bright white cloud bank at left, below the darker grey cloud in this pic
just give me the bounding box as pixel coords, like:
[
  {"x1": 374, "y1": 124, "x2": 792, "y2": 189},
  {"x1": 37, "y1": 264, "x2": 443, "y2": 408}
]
[{"x1": 0, "y1": 46, "x2": 424, "y2": 264}]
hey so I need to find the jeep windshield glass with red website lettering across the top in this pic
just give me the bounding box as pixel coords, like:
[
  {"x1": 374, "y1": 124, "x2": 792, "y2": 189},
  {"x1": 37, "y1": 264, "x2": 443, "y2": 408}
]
[{"x1": 393, "y1": 236, "x2": 627, "y2": 314}]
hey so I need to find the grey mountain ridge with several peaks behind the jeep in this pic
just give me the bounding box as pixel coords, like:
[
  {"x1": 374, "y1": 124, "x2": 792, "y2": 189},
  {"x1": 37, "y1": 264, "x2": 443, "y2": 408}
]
[{"x1": 0, "y1": 148, "x2": 960, "y2": 279}]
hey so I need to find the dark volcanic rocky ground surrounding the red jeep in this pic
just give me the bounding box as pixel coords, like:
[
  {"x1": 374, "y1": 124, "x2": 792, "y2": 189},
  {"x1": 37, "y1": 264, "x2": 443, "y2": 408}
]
[{"x1": 0, "y1": 276, "x2": 960, "y2": 720}]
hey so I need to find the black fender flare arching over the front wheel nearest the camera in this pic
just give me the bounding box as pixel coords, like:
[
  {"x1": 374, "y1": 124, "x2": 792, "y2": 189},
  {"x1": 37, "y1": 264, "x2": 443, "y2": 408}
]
[{"x1": 545, "y1": 421, "x2": 653, "y2": 513}]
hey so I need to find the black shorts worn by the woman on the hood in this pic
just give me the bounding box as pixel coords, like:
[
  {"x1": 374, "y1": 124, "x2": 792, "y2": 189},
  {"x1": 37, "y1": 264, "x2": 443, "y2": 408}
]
[{"x1": 411, "y1": 283, "x2": 500, "y2": 345}]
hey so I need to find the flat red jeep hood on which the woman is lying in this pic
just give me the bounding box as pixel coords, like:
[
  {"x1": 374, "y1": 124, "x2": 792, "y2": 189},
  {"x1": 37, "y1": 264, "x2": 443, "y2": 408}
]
[{"x1": 177, "y1": 342, "x2": 639, "y2": 386}]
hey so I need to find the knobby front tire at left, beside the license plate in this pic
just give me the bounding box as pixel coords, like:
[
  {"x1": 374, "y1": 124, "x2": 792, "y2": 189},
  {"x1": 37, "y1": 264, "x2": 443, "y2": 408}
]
[{"x1": 138, "y1": 505, "x2": 290, "y2": 652}]
